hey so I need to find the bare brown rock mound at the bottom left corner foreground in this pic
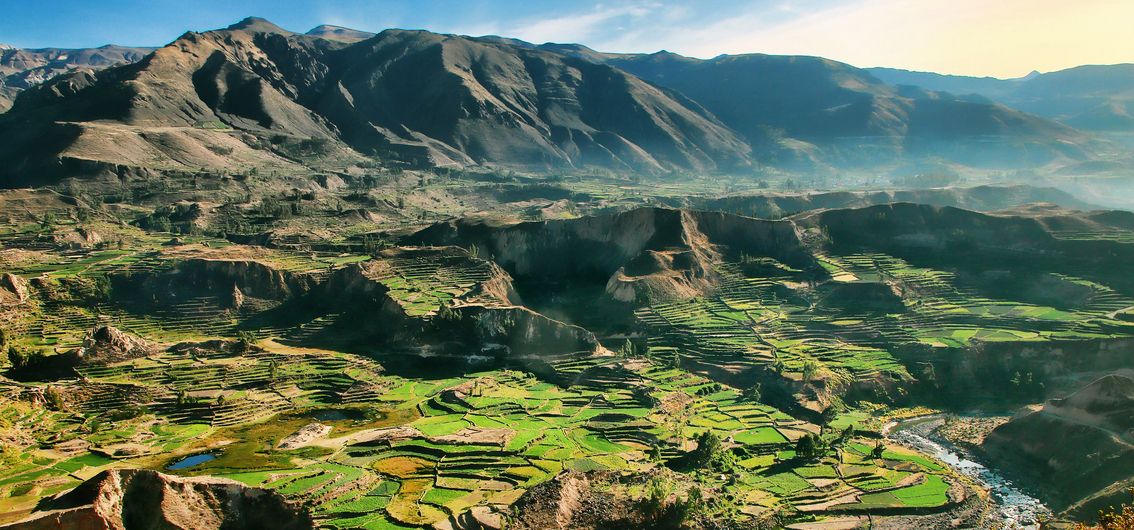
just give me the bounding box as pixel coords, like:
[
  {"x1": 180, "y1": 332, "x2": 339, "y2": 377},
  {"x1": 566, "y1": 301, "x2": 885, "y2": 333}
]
[{"x1": 0, "y1": 470, "x2": 314, "y2": 530}]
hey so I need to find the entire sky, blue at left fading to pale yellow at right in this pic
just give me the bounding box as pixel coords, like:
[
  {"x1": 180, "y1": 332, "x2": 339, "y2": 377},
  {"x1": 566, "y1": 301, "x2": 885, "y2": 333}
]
[{"x1": 0, "y1": 0, "x2": 1134, "y2": 77}]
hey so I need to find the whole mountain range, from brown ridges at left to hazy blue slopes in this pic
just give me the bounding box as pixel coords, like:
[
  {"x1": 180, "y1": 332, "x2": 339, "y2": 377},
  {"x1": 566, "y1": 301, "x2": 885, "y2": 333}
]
[{"x1": 0, "y1": 18, "x2": 1129, "y2": 186}]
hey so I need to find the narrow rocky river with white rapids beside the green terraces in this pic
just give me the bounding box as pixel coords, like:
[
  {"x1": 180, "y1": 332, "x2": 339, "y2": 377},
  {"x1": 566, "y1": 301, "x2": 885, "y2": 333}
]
[{"x1": 885, "y1": 415, "x2": 1051, "y2": 530}]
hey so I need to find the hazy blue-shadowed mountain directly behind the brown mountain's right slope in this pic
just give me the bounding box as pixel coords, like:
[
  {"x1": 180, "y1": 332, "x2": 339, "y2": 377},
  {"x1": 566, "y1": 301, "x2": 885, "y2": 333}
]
[{"x1": 603, "y1": 51, "x2": 1090, "y2": 167}]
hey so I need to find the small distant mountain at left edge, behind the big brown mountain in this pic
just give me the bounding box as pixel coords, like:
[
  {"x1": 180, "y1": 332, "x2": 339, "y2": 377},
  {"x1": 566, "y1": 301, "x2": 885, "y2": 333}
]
[{"x1": 0, "y1": 44, "x2": 153, "y2": 112}]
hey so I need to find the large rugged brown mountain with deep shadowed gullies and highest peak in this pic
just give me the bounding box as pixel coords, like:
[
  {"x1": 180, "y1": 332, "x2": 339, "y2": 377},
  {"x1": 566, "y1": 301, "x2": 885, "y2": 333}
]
[{"x1": 0, "y1": 19, "x2": 751, "y2": 187}]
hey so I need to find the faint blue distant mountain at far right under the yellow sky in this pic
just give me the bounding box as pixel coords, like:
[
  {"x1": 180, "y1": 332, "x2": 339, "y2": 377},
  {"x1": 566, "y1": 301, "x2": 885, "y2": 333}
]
[{"x1": 868, "y1": 64, "x2": 1134, "y2": 132}]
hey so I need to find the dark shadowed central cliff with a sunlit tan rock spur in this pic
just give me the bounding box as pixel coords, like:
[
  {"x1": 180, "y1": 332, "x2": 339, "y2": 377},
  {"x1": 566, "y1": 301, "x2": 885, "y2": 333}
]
[{"x1": 406, "y1": 208, "x2": 814, "y2": 302}]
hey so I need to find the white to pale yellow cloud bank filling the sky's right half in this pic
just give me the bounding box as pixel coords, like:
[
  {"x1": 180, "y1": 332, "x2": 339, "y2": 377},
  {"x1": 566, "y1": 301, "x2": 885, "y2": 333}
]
[{"x1": 537, "y1": 0, "x2": 1134, "y2": 77}]
